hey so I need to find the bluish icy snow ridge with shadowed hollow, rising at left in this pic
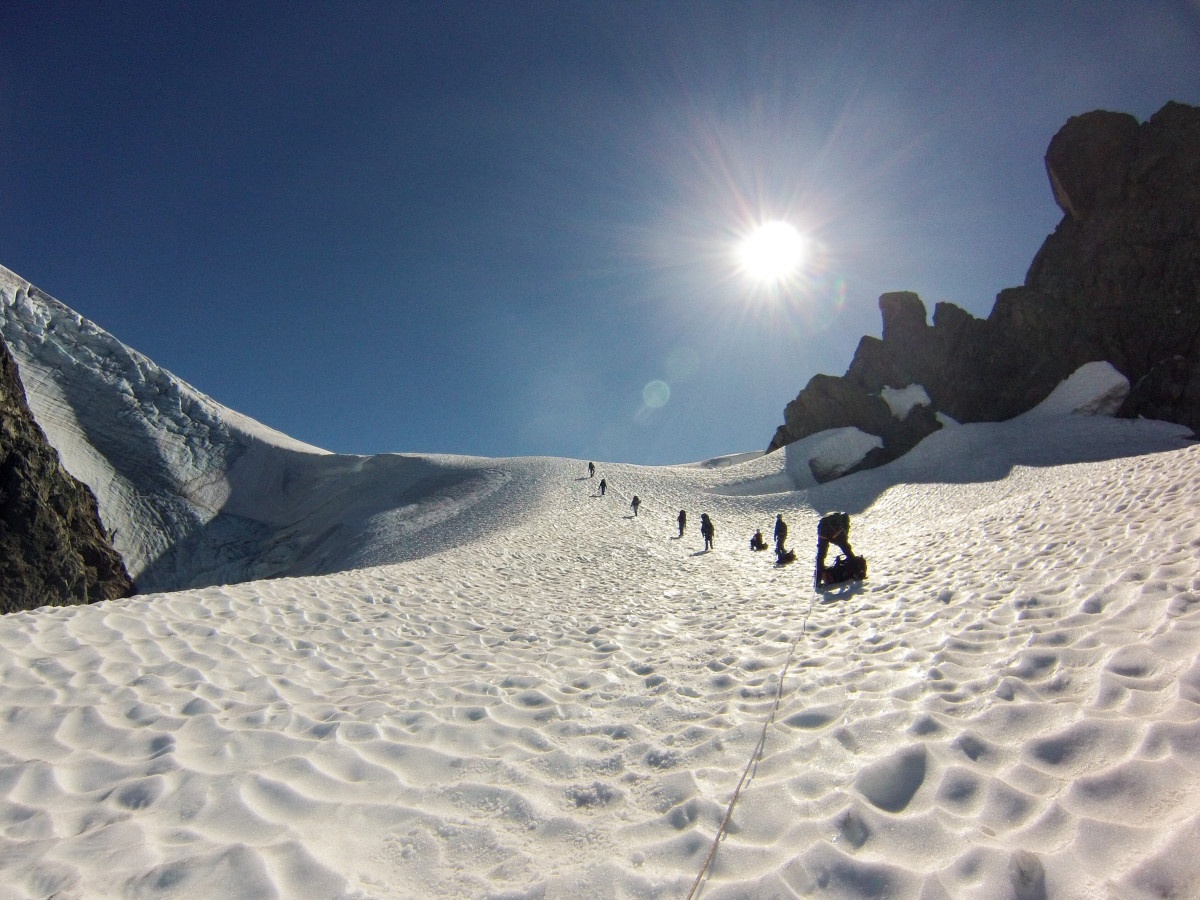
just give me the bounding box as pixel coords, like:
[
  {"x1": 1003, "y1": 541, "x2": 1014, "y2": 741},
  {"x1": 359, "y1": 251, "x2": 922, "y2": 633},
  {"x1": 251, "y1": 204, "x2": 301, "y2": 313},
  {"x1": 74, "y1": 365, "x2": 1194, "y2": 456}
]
[{"x1": 0, "y1": 268, "x2": 509, "y2": 592}]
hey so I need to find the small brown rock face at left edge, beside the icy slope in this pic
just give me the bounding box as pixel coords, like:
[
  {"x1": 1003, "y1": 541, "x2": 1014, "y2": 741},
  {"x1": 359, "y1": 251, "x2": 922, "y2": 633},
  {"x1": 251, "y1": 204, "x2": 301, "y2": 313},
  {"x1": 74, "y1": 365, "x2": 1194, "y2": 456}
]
[{"x1": 0, "y1": 341, "x2": 133, "y2": 613}]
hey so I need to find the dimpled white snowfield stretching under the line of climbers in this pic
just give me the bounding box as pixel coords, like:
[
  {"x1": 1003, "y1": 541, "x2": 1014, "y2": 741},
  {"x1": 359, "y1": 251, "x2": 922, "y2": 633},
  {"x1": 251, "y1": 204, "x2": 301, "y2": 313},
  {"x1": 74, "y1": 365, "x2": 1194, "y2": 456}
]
[{"x1": 0, "y1": 264, "x2": 1200, "y2": 900}]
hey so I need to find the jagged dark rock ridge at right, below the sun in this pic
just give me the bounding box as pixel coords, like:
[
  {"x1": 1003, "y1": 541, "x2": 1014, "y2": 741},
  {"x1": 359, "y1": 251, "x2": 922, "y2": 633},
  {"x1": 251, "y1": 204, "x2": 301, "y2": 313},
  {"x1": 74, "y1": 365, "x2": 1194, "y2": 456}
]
[{"x1": 768, "y1": 103, "x2": 1200, "y2": 464}]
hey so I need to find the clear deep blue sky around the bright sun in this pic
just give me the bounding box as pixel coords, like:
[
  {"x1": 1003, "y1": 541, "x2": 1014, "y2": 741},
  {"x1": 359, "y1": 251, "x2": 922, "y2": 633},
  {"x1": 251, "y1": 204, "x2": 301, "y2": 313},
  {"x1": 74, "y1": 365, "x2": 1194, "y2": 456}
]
[{"x1": 0, "y1": 0, "x2": 1200, "y2": 463}]
